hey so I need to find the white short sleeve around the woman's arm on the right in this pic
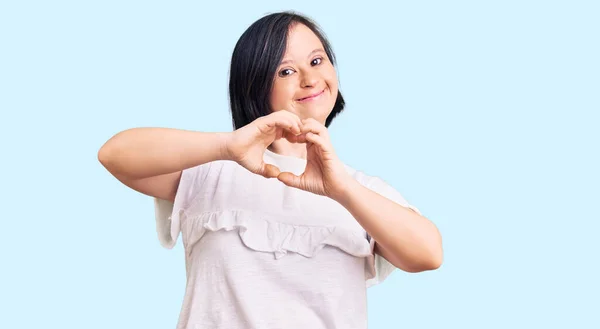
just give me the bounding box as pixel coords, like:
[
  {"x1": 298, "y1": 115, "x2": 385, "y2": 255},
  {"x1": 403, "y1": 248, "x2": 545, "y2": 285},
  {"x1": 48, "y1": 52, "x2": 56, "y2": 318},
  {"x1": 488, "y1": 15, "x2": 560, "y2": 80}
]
[{"x1": 360, "y1": 177, "x2": 422, "y2": 287}]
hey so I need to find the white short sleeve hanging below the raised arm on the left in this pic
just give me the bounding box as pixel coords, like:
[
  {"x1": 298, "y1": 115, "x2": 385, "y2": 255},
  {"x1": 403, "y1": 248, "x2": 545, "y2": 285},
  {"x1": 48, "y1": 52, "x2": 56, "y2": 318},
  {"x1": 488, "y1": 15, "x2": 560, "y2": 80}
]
[{"x1": 154, "y1": 165, "x2": 205, "y2": 249}]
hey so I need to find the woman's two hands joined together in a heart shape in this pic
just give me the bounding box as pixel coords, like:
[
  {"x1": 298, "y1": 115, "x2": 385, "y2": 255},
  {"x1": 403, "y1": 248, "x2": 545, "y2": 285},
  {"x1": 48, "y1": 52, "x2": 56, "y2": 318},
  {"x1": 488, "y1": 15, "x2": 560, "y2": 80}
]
[{"x1": 225, "y1": 110, "x2": 351, "y2": 197}]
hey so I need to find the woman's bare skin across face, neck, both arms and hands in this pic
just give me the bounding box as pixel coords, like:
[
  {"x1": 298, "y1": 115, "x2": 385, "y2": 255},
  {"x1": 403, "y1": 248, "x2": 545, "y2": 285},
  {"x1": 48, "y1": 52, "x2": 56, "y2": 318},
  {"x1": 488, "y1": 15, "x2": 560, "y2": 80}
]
[{"x1": 98, "y1": 25, "x2": 442, "y2": 272}]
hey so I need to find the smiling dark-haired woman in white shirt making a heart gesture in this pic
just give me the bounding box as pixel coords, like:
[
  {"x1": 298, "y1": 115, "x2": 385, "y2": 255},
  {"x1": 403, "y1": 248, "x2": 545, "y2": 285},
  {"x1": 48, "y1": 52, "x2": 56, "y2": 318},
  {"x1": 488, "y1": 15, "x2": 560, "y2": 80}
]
[{"x1": 99, "y1": 12, "x2": 442, "y2": 329}]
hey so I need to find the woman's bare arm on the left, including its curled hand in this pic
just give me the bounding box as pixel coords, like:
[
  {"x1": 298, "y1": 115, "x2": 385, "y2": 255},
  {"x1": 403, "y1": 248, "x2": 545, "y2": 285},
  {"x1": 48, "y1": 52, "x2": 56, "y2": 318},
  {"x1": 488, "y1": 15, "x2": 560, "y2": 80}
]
[{"x1": 98, "y1": 111, "x2": 301, "y2": 201}]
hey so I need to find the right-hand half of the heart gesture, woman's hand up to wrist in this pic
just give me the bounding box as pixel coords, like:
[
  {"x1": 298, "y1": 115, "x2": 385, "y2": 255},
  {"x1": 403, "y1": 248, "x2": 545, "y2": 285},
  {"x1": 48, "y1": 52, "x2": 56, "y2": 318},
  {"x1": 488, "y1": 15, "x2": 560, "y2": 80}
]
[{"x1": 277, "y1": 118, "x2": 352, "y2": 198}]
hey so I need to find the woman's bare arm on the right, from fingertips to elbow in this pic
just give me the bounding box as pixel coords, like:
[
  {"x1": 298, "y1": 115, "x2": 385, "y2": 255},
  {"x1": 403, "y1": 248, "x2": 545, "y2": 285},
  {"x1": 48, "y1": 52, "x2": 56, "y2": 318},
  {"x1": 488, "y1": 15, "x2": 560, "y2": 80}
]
[{"x1": 270, "y1": 118, "x2": 442, "y2": 272}]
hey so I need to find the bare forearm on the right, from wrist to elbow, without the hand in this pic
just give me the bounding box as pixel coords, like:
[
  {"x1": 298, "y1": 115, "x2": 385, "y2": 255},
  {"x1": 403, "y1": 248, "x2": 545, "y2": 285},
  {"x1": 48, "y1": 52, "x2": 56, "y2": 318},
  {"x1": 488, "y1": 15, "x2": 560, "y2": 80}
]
[{"x1": 335, "y1": 180, "x2": 443, "y2": 272}]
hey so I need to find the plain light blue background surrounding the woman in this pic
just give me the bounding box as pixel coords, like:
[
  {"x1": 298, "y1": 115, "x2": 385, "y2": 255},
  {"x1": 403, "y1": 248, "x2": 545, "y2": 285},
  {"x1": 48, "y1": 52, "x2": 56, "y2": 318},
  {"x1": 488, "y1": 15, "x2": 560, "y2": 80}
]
[{"x1": 0, "y1": 1, "x2": 600, "y2": 329}]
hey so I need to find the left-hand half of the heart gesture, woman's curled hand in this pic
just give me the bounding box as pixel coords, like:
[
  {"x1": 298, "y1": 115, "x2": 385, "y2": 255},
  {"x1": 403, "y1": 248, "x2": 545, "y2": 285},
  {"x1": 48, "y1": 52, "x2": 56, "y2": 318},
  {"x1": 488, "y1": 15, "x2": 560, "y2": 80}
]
[{"x1": 225, "y1": 110, "x2": 302, "y2": 178}]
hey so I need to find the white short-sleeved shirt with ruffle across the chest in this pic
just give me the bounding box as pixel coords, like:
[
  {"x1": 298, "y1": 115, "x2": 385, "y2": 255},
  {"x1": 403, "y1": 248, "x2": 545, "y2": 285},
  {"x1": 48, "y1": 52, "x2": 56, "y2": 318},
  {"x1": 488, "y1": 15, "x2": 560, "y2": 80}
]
[{"x1": 155, "y1": 150, "x2": 420, "y2": 329}]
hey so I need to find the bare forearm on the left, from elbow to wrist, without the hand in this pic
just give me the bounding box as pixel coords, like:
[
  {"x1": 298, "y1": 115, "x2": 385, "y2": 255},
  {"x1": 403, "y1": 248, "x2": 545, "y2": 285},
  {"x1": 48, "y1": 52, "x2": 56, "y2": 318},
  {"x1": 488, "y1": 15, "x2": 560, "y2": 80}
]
[{"x1": 98, "y1": 128, "x2": 228, "y2": 178}]
